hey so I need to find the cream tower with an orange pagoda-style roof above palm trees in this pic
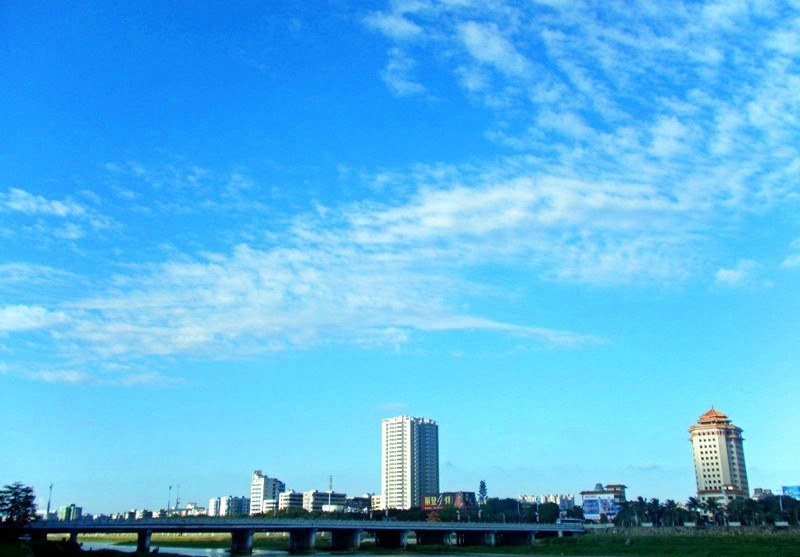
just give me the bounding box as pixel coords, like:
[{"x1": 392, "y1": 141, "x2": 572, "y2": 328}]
[{"x1": 689, "y1": 407, "x2": 750, "y2": 503}]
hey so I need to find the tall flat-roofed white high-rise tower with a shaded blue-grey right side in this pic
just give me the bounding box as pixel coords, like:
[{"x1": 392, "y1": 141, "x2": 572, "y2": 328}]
[{"x1": 381, "y1": 416, "x2": 439, "y2": 509}]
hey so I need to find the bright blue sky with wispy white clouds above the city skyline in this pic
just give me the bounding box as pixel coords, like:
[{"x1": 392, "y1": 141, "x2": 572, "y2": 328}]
[{"x1": 0, "y1": 0, "x2": 800, "y2": 513}]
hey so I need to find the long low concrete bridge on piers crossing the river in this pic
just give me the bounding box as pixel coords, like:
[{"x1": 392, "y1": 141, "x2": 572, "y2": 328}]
[{"x1": 29, "y1": 517, "x2": 586, "y2": 555}]
